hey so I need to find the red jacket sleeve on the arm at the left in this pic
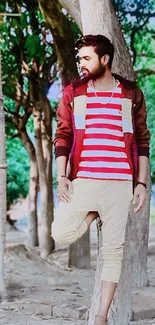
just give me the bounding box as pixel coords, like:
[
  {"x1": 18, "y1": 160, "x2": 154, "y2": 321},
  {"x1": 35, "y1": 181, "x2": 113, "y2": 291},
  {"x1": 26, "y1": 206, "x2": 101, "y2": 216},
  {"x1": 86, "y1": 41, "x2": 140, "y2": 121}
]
[{"x1": 53, "y1": 86, "x2": 73, "y2": 158}]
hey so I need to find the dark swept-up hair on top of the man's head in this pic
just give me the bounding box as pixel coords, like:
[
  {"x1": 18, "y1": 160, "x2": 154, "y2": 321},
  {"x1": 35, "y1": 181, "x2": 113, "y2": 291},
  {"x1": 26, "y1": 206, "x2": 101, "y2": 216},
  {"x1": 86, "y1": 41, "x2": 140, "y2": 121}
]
[{"x1": 75, "y1": 34, "x2": 114, "y2": 69}]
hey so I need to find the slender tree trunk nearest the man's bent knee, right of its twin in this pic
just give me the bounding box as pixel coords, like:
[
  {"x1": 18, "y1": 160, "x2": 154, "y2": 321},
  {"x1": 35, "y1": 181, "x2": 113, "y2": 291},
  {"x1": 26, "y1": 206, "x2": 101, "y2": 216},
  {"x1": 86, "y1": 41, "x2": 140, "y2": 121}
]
[{"x1": 33, "y1": 107, "x2": 53, "y2": 258}]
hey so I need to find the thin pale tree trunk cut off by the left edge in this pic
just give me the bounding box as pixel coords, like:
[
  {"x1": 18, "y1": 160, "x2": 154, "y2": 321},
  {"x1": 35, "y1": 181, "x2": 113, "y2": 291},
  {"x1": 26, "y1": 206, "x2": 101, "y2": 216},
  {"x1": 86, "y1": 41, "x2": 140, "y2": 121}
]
[{"x1": 0, "y1": 53, "x2": 6, "y2": 299}]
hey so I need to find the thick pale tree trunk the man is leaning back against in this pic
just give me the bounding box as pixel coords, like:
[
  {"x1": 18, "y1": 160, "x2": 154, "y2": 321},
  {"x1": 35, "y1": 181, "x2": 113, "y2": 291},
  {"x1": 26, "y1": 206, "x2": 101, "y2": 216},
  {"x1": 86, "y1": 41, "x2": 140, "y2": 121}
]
[{"x1": 75, "y1": 0, "x2": 149, "y2": 325}]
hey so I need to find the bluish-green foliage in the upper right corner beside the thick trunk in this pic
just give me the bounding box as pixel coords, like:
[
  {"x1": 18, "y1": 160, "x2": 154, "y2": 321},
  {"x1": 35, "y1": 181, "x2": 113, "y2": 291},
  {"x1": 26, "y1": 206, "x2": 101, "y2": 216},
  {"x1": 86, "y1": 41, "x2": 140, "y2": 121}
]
[{"x1": 113, "y1": 0, "x2": 155, "y2": 69}]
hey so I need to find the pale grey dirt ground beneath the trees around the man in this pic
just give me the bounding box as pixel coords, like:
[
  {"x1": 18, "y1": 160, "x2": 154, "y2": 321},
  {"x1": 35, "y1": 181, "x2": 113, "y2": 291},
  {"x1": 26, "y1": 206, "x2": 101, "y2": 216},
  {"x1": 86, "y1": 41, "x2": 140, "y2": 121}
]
[{"x1": 0, "y1": 223, "x2": 155, "y2": 325}]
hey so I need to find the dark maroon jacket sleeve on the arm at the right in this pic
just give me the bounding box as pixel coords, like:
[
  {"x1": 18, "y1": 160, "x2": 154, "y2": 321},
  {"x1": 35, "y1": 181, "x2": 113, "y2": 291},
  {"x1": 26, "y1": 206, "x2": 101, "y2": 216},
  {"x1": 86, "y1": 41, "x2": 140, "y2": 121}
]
[{"x1": 134, "y1": 88, "x2": 150, "y2": 157}]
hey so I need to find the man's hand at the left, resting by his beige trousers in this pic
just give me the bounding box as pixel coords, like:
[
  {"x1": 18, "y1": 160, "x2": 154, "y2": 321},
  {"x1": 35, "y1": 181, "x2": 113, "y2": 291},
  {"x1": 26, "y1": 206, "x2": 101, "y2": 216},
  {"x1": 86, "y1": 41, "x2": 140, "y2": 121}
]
[{"x1": 57, "y1": 177, "x2": 73, "y2": 203}]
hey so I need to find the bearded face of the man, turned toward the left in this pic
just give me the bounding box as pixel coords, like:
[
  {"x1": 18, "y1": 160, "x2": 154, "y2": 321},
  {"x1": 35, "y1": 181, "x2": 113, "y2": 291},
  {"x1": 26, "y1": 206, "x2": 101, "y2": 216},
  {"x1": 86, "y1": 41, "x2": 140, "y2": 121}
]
[{"x1": 79, "y1": 46, "x2": 106, "y2": 80}]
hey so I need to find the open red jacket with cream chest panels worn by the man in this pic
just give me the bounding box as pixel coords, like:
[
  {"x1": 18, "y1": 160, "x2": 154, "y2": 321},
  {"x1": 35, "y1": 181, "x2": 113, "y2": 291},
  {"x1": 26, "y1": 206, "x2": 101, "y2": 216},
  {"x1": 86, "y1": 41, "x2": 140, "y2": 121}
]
[{"x1": 54, "y1": 75, "x2": 150, "y2": 184}]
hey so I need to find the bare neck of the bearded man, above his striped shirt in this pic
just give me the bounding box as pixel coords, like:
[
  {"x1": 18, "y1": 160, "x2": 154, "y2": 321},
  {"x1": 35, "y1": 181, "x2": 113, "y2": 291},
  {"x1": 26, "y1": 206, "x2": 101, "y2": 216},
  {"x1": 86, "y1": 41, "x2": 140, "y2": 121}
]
[{"x1": 90, "y1": 70, "x2": 115, "y2": 91}]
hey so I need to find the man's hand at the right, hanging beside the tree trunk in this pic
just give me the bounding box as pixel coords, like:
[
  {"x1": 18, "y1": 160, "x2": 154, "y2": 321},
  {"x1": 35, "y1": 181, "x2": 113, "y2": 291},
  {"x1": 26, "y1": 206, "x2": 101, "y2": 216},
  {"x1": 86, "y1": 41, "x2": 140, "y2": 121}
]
[{"x1": 132, "y1": 184, "x2": 146, "y2": 213}]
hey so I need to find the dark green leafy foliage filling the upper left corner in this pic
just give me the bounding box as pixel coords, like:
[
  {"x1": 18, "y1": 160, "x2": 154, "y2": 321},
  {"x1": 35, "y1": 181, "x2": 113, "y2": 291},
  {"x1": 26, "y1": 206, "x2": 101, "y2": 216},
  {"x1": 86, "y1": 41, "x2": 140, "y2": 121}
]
[{"x1": 0, "y1": 0, "x2": 55, "y2": 98}]
